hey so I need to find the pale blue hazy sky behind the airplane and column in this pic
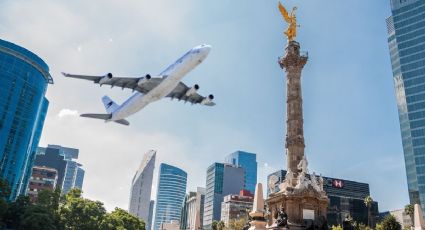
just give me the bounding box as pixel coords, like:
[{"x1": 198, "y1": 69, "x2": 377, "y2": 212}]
[{"x1": 0, "y1": 0, "x2": 408, "y2": 211}]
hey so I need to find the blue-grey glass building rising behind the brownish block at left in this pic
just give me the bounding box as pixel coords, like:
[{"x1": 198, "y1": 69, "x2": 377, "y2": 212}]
[{"x1": 34, "y1": 145, "x2": 84, "y2": 194}]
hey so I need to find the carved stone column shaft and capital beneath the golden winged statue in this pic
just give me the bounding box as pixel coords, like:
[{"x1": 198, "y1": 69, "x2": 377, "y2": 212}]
[{"x1": 279, "y1": 41, "x2": 308, "y2": 174}]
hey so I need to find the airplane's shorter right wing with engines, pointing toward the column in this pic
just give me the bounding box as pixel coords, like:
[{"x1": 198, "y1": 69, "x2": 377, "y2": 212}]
[{"x1": 167, "y1": 82, "x2": 215, "y2": 106}]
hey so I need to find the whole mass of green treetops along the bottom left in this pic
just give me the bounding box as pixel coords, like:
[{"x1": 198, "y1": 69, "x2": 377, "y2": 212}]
[{"x1": 0, "y1": 180, "x2": 145, "y2": 230}]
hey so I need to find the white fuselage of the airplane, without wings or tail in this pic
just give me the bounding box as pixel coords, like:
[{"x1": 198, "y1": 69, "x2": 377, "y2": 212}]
[{"x1": 106, "y1": 45, "x2": 211, "y2": 121}]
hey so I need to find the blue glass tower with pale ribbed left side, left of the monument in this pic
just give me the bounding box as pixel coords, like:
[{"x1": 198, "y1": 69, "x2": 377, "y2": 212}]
[{"x1": 203, "y1": 163, "x2": 245, "y2": 229}]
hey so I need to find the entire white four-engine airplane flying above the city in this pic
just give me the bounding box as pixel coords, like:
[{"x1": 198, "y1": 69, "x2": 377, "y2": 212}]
[{"x1": 62, "y1": 44, "x2": 215, "y2": 125}]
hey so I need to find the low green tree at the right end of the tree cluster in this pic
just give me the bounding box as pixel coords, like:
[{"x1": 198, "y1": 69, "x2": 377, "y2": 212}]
[{"x1": 100, "y1": 208, "x2": 145, "y2": 230}]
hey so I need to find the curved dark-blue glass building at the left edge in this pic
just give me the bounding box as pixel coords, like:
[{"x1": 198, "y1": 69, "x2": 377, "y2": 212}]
[{"x1": 0, "y1": 40, "x2": 53, "y2": 200}]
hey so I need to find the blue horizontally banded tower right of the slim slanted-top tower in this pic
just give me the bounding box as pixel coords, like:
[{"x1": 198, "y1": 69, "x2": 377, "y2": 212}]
[{"x1": 153, "y1": 163, "x2": 187, "y2": 230}]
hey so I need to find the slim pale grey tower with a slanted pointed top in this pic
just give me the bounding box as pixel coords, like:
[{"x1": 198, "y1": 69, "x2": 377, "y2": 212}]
[{"x1": 128, "y1": 150, "x2": 156, "y2": 225}]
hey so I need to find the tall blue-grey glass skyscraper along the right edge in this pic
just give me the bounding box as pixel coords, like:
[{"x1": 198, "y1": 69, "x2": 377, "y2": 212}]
[{"x1": 387, "y1": 0, "x2": 425, "y2": 209}]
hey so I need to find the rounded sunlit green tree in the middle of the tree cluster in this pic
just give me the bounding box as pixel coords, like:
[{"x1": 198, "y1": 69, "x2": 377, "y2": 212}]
[{"x1": 59, "y1": 189, "x2": 106, "y2": 230}]
